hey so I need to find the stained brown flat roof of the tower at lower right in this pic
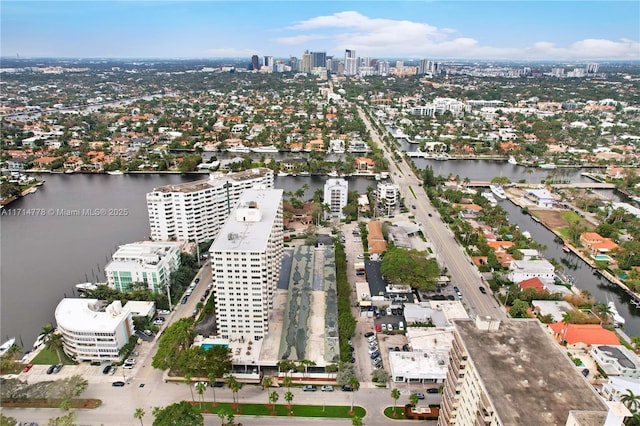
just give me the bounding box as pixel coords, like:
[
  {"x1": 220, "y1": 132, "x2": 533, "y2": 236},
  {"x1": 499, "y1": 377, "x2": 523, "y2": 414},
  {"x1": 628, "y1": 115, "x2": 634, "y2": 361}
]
[{"x1": 454, "y1": 319, "x2": 607, "y2": 425}]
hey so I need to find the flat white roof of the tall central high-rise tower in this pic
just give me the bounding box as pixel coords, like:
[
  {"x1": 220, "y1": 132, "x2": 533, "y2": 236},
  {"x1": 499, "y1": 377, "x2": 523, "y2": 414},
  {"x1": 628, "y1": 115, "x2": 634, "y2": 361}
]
[{"x1": 209, "y1": 189, "x2": 283, "y2": 253}]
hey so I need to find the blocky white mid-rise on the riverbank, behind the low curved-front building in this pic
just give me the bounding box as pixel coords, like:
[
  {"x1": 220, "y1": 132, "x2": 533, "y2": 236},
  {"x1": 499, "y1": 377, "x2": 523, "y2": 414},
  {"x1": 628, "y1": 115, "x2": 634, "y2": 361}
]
[{"x1": 104, "y1": 241, "x2": 180, "y2": 293}]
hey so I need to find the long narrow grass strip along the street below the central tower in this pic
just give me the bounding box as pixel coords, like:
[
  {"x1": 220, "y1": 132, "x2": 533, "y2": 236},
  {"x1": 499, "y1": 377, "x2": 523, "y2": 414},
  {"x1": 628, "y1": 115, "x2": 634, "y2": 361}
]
[{"x1": 200, "y1": 402, "x2": 367, "y2": 419}]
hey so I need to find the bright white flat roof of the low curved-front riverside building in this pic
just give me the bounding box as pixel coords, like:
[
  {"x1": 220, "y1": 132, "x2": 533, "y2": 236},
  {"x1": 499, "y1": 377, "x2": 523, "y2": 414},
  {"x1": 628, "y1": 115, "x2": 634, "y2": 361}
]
[{"x1": 55, "y1": 298, "x2": 129, "y2": 333}]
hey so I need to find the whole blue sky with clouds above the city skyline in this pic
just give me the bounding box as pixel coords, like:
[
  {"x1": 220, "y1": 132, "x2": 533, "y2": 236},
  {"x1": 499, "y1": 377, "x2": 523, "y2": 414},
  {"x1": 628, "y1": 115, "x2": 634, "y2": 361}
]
[{"x1": 0, "y1": 0, "x2": 640, "y2": 61}]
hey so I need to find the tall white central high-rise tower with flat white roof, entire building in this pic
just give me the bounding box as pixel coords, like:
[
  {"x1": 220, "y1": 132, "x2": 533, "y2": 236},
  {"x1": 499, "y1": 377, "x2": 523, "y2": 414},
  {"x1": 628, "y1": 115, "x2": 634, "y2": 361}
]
[{"x1": 209, "y1": 189, "x2": 283, "y2": 340}]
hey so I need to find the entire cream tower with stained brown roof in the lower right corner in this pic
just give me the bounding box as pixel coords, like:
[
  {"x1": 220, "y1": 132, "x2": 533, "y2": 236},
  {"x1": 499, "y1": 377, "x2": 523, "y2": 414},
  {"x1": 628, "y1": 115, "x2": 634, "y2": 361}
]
[{"x1": 438, "y1": 317, "x2": 621, "y2": 426}]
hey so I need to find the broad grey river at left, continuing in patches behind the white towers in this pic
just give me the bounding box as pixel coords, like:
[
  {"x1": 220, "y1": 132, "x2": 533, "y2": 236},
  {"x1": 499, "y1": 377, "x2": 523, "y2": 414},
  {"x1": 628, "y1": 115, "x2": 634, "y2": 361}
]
[{"x1": 0, "y1": 174, "x2": 375, "y2": 349}]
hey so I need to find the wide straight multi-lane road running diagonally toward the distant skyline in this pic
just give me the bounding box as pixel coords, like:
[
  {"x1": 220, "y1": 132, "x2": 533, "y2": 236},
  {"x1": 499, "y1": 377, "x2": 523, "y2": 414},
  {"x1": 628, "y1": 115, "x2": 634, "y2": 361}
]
[{"x1": 357, "y1": 106, "x2": 507, "y2": 319}]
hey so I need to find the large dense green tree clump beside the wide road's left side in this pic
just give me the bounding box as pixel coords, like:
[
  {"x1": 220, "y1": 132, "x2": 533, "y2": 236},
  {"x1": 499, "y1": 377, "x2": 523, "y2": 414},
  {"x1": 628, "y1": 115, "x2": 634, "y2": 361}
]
[{"x1": 380, "y1": 248, "x2": 440, "y2": 290}]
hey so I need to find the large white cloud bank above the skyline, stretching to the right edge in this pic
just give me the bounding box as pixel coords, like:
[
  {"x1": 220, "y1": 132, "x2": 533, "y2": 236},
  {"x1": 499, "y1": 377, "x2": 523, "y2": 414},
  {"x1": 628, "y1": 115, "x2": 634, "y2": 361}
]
[{"x1": 275, "y1": 11, "x2": 640, "y2": 59}]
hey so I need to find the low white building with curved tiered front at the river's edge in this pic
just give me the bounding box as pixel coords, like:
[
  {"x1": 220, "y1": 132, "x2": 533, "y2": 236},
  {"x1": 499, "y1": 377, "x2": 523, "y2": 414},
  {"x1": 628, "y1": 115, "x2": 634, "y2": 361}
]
[{"x1": 55, "y1": 298, "x2": 135, "y2": 362}]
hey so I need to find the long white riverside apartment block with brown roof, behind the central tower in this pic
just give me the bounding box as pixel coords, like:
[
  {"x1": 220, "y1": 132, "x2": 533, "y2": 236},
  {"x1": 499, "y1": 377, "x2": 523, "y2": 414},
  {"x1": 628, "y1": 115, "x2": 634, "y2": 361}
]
[{"x1": 147, "y1": 168, "x2": 273, "y2": 242}]
